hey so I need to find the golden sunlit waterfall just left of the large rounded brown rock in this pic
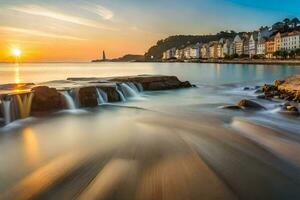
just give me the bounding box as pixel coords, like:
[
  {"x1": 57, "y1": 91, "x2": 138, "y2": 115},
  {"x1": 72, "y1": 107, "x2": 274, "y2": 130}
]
[{"x1": 16, "y1": 93, "x2": 34, "y2": 119}]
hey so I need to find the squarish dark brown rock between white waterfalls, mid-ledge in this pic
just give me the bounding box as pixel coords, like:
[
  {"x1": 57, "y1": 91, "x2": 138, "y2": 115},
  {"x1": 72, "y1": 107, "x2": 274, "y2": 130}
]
[{"x1": 78, "y1": 87, "x2": 98, "y2": 108}]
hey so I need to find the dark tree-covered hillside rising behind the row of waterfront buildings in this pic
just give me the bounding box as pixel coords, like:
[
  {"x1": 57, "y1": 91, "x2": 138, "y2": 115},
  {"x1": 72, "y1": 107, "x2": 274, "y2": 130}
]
[{"x1": 145, "y1": 31, "x2": 237, "y2": 61}]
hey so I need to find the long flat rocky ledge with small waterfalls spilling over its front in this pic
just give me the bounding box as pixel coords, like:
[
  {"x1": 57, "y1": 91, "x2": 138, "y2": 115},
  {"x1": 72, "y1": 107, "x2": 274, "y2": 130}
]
[{"x1": 0, "y1": 75, "x2": 192, "y2": 125}]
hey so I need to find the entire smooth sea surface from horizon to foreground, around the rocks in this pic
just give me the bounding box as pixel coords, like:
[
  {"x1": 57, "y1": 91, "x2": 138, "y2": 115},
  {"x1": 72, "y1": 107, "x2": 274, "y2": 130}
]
[{"x1": 0, "y1": 63, "x2": 300, "y2": 200}]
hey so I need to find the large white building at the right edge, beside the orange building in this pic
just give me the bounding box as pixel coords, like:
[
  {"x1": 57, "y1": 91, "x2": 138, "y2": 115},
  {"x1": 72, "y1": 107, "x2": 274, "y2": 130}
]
[{"x1": 280, "y1": 31, "x2": 300, "y2": 51}]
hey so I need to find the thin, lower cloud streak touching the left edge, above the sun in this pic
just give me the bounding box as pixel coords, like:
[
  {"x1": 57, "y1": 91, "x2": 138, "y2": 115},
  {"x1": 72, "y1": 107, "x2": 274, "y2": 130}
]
[{"x1": 0, "y1": 26, "x2": 86, "y2": 40}]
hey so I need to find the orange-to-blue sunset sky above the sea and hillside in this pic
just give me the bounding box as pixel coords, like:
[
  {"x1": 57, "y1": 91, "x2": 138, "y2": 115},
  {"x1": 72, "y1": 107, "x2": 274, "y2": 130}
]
[{"x1": 0, "y1": 0, "x2": 300, "y2": 62}]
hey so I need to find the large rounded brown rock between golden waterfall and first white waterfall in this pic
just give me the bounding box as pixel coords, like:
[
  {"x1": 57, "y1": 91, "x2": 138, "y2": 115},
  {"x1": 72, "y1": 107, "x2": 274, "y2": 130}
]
[{"x1": 31, "y1": 86, "x2": 64, "y2": 114}]
